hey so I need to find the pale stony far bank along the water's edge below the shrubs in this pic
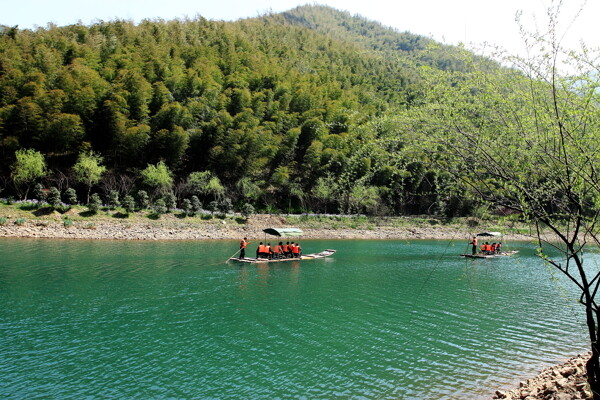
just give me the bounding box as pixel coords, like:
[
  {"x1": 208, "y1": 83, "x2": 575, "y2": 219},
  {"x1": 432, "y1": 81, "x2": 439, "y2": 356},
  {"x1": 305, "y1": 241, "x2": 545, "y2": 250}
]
[{"x1": 0, "y1": 213, "x2": 534, "y2": 243}]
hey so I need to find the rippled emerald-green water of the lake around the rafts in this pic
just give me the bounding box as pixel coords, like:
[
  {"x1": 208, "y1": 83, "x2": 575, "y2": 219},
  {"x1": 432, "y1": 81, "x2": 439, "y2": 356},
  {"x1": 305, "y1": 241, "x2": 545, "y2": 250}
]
[{"x1": 0, "y1": 239, "x2": 593, "y2": 399}]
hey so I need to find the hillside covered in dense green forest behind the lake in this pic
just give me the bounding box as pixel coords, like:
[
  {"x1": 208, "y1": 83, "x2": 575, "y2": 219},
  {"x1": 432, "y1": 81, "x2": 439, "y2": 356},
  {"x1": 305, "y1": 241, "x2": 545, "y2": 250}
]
[{"x1": 0, "y1": 6, "x2": 488, "y2": 215}]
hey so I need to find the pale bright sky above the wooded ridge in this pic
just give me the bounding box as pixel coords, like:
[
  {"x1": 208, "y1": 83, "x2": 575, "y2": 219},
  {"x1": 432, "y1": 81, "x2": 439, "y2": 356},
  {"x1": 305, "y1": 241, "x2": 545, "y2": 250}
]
[{"x1": 0, "y1": 0, "x2": 600, "y2": 53}]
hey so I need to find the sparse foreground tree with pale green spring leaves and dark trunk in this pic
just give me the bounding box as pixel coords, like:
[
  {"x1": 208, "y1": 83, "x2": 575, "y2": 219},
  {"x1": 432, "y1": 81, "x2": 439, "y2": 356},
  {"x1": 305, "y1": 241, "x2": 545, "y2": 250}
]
[{"x1": 420, "y1": 3, "x2": 600, "y2": 399}]
